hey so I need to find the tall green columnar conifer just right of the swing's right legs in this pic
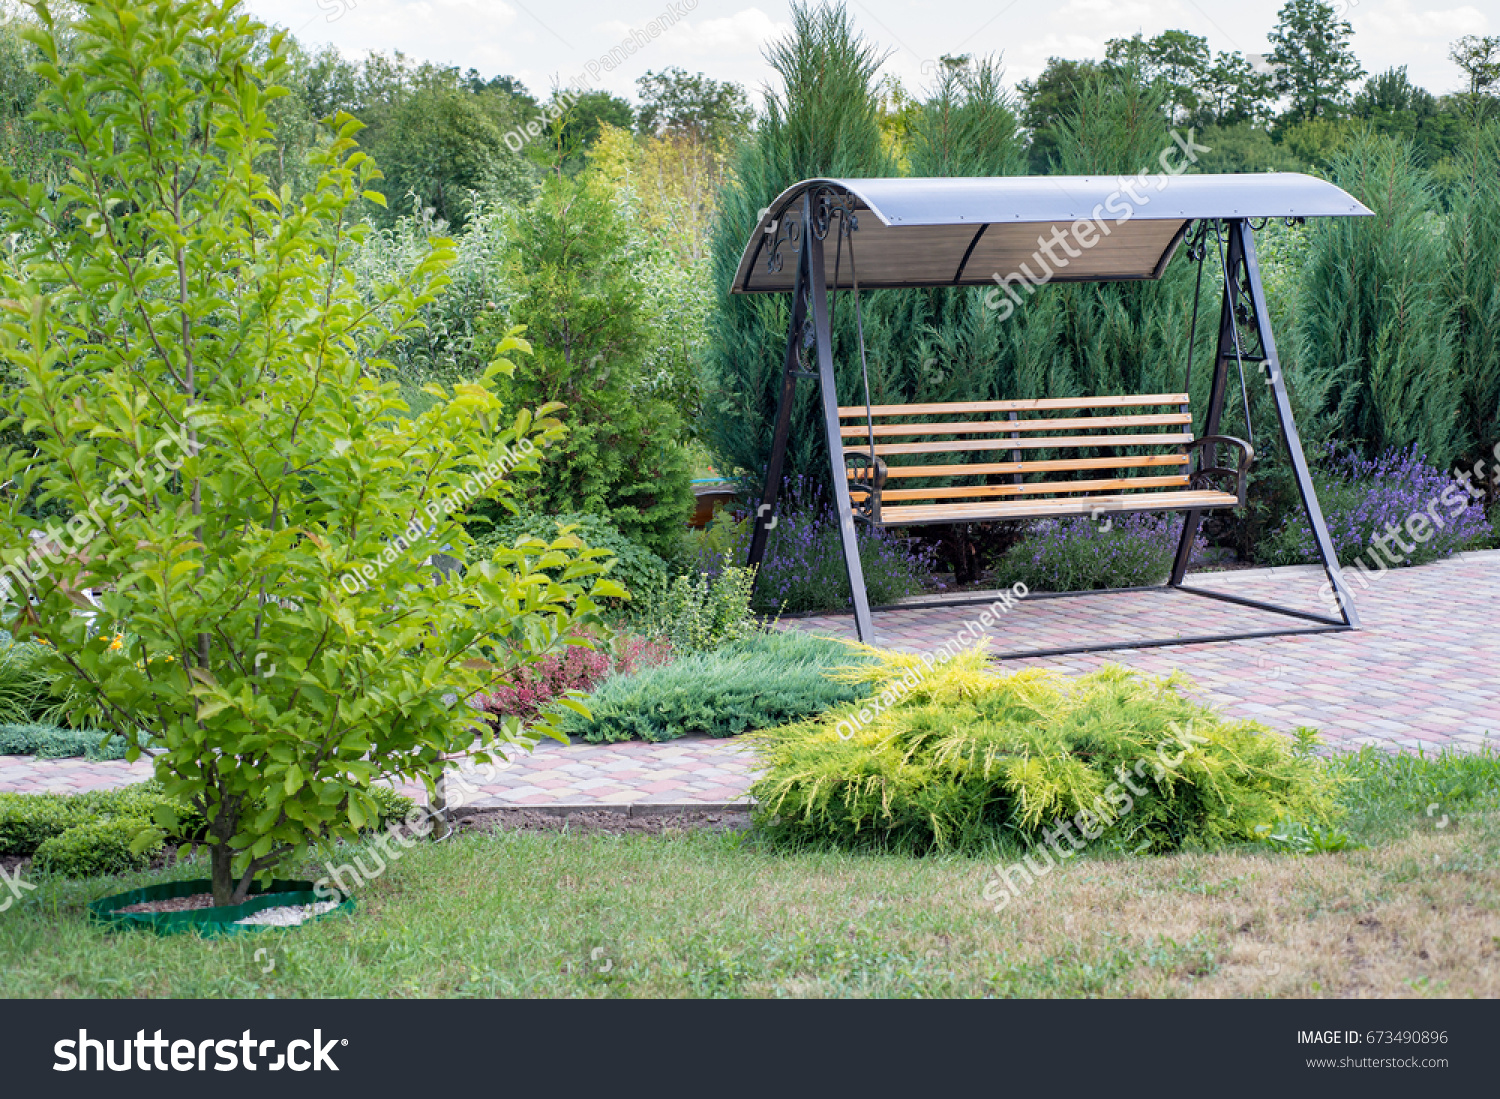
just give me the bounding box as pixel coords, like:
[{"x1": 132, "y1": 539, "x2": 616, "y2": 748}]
[{"x1": 1289, "y1": 136, "x2": 1463, "y2": 466}]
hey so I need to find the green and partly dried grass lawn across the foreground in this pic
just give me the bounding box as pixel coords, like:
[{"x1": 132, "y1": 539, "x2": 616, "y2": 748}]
[{"x1": 0, "y1": 749, "x2": 1500, "y2": 997}]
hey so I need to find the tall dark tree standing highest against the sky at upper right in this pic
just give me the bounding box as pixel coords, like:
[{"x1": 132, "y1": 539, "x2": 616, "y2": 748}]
[{"x1": 1266, "y1": 0, "x2": 1365, "y2": 121}]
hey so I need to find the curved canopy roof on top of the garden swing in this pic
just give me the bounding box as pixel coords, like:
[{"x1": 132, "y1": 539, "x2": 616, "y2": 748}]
[{"x1": 731, "y1": 172, "x2": 1371, "y2": 294}]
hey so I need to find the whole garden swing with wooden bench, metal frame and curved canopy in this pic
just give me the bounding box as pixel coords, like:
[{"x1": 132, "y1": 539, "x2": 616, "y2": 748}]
[{"x1": 731, "y1": 172, "x2": 1370, "y2": 658}]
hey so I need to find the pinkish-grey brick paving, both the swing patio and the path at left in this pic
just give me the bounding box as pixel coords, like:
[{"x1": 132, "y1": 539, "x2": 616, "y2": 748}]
[{"x1": 0, "y1": 552, "x2": 1500, "y2": 808}]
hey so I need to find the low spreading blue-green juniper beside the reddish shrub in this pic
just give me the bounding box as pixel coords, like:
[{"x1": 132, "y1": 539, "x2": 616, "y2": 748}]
[{"x1": 564, "y1": 630, "x2": 867, "y2": 744}]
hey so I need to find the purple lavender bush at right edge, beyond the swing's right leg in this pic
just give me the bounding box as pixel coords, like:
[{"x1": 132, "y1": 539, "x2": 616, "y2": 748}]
[{"x1": 1262, "y1": 448, "x2": 1491, "y2": 567}]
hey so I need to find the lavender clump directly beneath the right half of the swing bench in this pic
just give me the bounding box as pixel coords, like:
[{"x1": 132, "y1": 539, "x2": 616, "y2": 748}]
[{"x1": 995, "y1": 513, "x2": 1208, "y2": 591}]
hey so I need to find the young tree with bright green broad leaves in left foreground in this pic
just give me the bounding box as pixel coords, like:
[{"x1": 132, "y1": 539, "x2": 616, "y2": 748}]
[{"x1": 0, "y1": 0, "x2": 621, "y2": 904}]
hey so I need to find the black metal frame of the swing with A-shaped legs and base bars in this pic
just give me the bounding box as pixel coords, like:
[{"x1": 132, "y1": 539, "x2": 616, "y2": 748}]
[{"x1": 746, "y1": 203, "x2": 1359, "y2": 660}]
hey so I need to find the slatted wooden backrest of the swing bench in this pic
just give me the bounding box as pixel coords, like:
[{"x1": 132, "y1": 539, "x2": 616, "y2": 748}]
[{"x1": 839, "y1": 393, "x2": 1193, "y2": 501}]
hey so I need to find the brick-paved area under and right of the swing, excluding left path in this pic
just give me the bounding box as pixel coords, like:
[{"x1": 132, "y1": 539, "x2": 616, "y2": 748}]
[{"x1": 786, "y1": 550, "x2": 1500, "y2": 750}]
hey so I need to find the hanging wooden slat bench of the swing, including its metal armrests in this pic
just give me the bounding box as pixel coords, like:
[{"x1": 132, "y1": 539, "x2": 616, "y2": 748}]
[{"x1": 839, "y1": 393, "x2": 1254, "y2": 526}]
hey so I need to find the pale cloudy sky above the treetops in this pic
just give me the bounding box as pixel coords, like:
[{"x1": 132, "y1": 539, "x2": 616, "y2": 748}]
[{"x1": 249, "y1": 0, "x2": 1500, "y2": 102}]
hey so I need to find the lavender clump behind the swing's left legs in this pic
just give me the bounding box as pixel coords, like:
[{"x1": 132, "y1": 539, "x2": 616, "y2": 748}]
[{"x1": 690, "y1": 478, "x2": 936, "y2": 613}]
